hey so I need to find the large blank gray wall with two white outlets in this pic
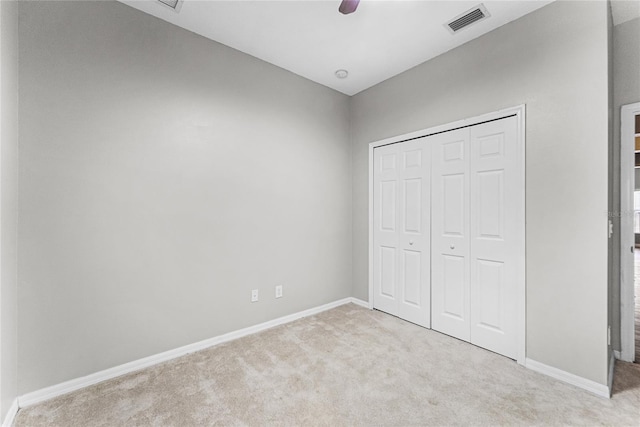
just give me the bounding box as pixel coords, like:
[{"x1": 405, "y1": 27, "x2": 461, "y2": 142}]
[{"x1": 19, "y1": 2, "x2": 351, "y2": 393}]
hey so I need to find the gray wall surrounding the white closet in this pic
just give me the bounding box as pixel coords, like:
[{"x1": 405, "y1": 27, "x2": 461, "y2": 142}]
[{"x1": 351, "y1": 2, "x2": 608, "y2": 384}]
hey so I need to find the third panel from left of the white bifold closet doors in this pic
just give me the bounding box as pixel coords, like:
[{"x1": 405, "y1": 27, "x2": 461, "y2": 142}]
[{"x1": 428, "y1": 128, "x2": 470, "y2": 341}]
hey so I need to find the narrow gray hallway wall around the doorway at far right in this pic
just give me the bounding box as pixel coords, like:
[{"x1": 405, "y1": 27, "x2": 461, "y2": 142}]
[{"x1": 611, "y1": 18, "x2": 640, "y2": 350}]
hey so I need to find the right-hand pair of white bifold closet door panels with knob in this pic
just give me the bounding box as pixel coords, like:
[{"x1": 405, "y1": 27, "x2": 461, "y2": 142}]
[{"x1": 428, "y1": 117, "x2": 524, "y2": 358}]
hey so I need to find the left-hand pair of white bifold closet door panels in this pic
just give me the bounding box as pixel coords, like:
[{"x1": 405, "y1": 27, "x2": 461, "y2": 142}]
[{"x1": 373, "y1": 139, "x2": 431, "y2": 327}]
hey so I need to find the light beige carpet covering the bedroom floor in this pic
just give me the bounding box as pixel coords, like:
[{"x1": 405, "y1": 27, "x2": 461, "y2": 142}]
[{"x1": 15, "y1": 304, "x2": 640, "y2": 426}]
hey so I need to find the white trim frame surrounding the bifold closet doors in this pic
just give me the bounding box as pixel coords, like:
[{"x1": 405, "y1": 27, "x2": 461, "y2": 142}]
[{"x1": 369, "y1": 104, "x2": 527, "y2": 365}]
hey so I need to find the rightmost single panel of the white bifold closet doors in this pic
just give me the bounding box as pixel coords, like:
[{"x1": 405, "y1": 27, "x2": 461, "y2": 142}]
[{"x1": 469, "y1": 117, "x2": 524, "y2": 358}]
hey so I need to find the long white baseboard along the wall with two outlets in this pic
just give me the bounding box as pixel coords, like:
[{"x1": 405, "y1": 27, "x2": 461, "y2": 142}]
[{"x1": 21, "y1": 297, "x2": 360, "y2": 410}]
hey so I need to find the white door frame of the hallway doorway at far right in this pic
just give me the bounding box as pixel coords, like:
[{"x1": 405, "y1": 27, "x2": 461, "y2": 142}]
[{"x1": 620, "y1": 102, "x2": 640, "y2": 362}]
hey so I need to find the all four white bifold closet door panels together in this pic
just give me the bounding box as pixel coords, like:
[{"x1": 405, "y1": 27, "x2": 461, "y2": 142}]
[{"x1": 372, "y1": 115, "x2": 524, "y2": 359}]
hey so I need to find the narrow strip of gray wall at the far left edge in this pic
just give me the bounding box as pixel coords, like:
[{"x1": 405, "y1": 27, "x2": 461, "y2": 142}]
[{"x1": 0, "y1": 1, "x2": 18, "y2": 420}]
